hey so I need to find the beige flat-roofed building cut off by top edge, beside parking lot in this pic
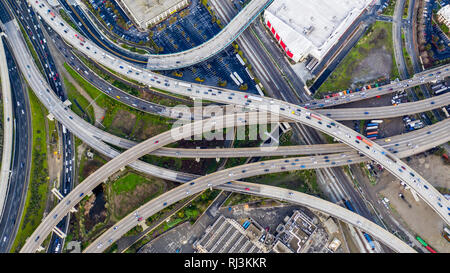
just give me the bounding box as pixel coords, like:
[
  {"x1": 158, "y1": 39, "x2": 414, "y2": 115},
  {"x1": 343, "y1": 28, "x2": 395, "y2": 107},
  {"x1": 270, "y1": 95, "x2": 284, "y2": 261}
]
[{"x1": 117, "y1": 0, "x2": 190, "y2": 28}]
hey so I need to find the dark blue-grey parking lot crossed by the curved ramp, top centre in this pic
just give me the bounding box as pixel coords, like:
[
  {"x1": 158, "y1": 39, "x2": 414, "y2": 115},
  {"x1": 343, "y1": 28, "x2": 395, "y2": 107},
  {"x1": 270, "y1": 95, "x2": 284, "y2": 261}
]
[{"x1": 151, "y1": 0, "x2": 257, "y2": 94}]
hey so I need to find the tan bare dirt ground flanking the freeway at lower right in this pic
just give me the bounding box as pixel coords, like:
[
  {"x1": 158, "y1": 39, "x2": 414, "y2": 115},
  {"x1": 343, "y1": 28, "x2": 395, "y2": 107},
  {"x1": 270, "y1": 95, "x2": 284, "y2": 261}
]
[{"x1": 376, "y1": 154, "x2": 450, "y2": 253}]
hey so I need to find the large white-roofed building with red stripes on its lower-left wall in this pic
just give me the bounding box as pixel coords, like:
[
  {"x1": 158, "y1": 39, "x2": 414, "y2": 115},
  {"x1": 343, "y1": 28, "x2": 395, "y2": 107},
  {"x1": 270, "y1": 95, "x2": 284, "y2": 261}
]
[{"x1": 264, "y1": 0, "x2": 375, "y2": 62}]
